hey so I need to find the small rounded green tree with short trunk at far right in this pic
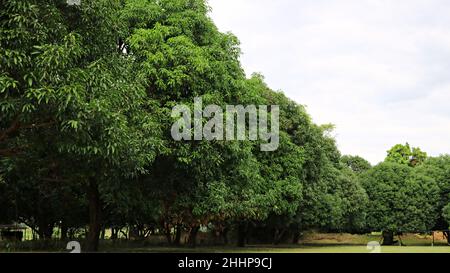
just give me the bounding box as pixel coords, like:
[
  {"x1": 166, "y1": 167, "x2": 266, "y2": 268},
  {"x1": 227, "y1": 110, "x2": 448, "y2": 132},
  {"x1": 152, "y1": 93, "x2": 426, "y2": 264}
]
[{"x1": 361, "y1": 162, "x2": 439, "y2": 245}]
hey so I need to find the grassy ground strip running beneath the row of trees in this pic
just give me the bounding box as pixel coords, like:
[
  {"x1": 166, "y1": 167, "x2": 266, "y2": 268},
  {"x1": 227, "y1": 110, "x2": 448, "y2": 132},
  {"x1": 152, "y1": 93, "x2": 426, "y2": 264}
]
[{"x1": 0, "y1": 233, "x2": 450, "y2": 254}]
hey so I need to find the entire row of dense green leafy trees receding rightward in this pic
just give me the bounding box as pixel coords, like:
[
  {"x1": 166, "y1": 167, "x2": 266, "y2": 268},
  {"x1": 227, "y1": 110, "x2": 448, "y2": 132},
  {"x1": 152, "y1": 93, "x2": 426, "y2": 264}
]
[{"x1": 0, "y1": 0, "x2": 450, "y2": 251}]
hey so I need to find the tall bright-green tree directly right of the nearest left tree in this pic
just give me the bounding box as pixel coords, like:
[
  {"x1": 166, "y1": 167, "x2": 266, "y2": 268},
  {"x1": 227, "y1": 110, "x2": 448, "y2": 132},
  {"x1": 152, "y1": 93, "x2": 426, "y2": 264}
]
[{"x1": 121, "y1": 1, "x2": 260, "y2": 245}]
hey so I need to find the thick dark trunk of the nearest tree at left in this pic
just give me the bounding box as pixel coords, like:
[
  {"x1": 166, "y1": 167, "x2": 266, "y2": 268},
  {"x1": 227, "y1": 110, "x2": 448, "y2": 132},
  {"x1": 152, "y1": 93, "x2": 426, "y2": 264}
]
[{"x1": 86, "y1": 179, "x2": 101, "y2": 252}]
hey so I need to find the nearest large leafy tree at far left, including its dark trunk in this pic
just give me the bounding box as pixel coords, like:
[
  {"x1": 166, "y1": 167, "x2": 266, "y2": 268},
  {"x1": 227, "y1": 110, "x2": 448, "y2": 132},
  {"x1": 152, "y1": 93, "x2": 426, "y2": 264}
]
[{"x1": 0, "y1": 0, "x2": 161, "y2": 251}]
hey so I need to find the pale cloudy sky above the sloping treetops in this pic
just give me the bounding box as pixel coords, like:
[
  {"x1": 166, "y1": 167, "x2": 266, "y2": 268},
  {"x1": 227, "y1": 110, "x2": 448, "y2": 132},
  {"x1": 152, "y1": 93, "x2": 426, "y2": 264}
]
[{"x1": 209, "y1": 0, "x2": 450, "y2": 164}]
